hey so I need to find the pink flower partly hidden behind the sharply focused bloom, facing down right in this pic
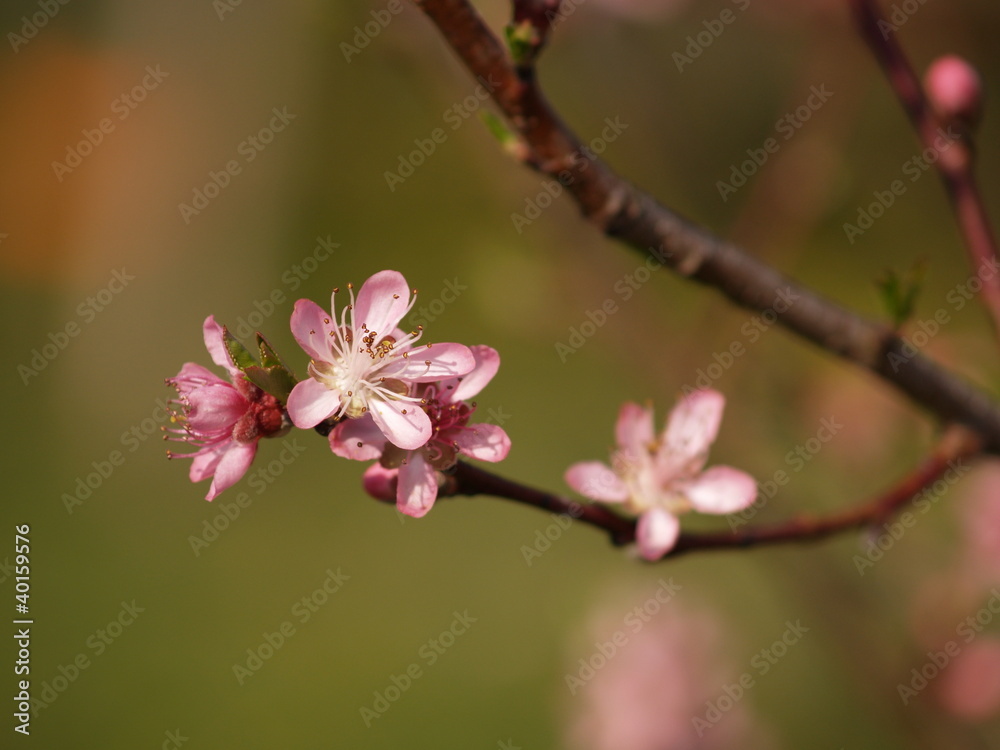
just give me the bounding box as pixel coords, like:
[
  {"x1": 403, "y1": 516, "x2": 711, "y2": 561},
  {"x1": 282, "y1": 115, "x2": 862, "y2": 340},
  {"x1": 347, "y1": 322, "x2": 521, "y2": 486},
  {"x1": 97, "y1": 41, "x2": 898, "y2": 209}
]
[{"x1": 330, "y1": 346, "x2": 510, "y2": 518}]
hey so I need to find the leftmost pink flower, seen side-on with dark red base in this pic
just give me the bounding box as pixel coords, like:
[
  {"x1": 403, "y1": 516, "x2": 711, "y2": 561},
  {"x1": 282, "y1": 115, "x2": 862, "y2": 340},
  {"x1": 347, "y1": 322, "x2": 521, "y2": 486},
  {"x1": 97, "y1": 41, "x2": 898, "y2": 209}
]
[{"x1": 166, "y1": 315, "x2": 285, "y2": 500}]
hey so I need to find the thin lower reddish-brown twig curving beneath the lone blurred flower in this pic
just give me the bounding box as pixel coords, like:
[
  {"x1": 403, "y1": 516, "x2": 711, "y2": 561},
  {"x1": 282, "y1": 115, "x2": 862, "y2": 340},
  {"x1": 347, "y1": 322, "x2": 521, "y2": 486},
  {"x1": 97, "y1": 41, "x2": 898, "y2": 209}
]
[{"x1": 440, "y1": 428, "x2": 981, "y2": 560}]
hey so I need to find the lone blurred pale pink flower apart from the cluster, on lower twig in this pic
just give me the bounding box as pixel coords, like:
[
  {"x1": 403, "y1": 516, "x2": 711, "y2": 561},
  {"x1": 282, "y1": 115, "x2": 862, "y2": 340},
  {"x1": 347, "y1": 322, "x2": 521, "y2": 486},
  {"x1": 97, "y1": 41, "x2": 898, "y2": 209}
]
[{"x1": 566, "y1": 389, "x2": 757, "y2": 560}]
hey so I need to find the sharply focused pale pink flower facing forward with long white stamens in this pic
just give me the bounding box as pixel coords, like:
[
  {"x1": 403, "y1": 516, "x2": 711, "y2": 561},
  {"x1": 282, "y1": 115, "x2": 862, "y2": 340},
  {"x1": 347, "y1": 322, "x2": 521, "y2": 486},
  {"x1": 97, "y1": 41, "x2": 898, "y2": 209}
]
[{"x1": 288, "y1": 271, "x2": 474, "y2": 450}]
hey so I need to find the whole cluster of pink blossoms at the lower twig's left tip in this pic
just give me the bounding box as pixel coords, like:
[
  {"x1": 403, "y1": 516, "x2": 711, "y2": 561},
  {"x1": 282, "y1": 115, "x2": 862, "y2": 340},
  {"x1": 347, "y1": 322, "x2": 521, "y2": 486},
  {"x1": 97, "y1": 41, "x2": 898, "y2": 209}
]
[{"x1": 167, "y1": 271, "x2": 510, "y2": 517}]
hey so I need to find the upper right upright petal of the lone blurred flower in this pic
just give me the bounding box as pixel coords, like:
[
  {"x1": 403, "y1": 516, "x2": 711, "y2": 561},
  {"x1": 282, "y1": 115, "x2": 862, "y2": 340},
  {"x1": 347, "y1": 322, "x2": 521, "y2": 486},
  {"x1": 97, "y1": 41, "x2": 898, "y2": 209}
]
[{"x1": 657, "y1": 389, "x2": 726, "y2": 476}]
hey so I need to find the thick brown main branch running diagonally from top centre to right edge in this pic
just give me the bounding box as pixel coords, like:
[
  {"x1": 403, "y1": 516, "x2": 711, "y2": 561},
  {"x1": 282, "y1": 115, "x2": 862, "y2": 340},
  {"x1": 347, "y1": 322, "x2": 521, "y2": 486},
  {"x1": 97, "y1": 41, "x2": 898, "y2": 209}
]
[{"x1": 414, "y1": 0, "x2": 1000, "y2": 452}]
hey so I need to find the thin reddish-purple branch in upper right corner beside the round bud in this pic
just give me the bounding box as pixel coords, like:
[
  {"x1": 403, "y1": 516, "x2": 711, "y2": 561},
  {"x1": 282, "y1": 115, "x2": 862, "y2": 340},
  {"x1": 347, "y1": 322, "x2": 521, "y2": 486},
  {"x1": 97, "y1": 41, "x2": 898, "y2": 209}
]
[{"x1": 851, "y1": 0, "x2": 1000, "y2": 344}]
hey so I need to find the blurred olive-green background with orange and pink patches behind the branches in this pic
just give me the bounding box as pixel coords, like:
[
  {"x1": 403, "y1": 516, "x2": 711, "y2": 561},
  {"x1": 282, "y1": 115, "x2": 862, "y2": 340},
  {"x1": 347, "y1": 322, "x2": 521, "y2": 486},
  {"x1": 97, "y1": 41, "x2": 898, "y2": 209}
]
[{"x1": 0, "y1": 0, "x2": 1000, "y2": 750}]
